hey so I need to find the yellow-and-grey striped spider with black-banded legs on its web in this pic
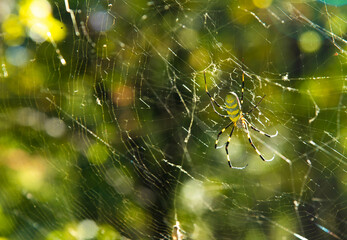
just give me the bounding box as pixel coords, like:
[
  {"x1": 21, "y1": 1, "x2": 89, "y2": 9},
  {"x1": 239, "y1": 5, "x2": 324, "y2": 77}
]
[{"x1": 204, "y1": 72, "x2": 278, "y2": 169}]
